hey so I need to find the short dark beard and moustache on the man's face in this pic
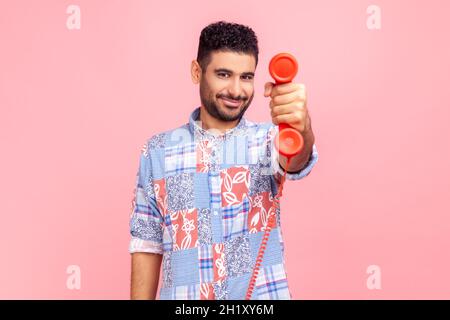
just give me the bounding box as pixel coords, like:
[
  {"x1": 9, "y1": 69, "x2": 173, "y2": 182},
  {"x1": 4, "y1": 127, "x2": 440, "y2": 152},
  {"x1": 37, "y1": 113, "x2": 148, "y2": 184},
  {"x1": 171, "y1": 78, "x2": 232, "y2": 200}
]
[{"x1": 200, "y1": 80, "x2": 255, "y2": 122}]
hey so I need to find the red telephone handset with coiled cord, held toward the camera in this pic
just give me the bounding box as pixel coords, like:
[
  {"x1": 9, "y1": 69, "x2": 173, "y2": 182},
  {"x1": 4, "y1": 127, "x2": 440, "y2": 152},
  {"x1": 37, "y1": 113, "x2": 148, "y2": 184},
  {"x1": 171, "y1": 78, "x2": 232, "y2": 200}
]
[{"x1": 245, "y1": 53, "x2": 304, "y2": 300}]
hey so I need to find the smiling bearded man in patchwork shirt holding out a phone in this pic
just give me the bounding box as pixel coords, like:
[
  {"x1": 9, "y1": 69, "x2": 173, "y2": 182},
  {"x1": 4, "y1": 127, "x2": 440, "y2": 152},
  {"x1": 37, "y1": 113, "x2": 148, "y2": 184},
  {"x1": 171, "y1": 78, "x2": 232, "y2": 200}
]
[{"x1": 129, "y1": 21, "x2": 318, "y2": 299}]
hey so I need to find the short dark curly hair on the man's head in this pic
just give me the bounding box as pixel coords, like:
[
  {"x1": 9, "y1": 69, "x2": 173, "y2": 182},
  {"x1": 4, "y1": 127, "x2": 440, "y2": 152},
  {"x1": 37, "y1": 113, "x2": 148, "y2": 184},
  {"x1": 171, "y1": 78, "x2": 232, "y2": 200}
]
[{"x1": 197, "y1": 21, "x2": 259, "y2": 73}]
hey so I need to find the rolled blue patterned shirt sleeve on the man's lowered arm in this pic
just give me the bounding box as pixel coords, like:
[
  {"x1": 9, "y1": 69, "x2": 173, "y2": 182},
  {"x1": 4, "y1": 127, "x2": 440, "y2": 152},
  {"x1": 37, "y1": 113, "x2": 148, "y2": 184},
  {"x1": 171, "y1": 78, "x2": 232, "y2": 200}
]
[{"x1": 128, "y1": 141, "x2": 163, "y2": 254}]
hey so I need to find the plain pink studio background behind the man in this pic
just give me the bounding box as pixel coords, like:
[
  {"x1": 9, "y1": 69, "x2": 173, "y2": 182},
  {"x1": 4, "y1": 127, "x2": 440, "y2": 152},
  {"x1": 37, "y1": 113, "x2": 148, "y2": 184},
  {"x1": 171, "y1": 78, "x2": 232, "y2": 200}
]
[{"x1": 0, "y1": 0, "x2": 450, "y2": 299}]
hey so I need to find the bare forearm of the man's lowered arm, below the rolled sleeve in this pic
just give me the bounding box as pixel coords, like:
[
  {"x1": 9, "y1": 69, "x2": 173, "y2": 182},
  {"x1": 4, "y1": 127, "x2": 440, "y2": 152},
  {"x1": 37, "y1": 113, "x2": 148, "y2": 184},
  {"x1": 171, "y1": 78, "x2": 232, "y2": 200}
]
[{"x1": 130, "y1": 252, "x2": 162, "y2": 300}]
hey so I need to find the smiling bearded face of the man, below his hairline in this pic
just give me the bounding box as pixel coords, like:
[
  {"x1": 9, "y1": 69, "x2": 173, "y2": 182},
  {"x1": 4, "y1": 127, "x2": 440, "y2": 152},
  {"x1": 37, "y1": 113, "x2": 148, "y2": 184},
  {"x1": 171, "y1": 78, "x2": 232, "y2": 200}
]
[{"x1": 195, "y1": 52, "x2": 256, "y2": 121}]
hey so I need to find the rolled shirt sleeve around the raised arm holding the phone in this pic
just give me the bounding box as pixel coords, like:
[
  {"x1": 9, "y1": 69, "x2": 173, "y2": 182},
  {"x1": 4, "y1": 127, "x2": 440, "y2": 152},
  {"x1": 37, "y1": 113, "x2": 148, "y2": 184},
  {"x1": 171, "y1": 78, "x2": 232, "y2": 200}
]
[{"x1": 268, "y1": 125, "x2": 319, "y2": 182}]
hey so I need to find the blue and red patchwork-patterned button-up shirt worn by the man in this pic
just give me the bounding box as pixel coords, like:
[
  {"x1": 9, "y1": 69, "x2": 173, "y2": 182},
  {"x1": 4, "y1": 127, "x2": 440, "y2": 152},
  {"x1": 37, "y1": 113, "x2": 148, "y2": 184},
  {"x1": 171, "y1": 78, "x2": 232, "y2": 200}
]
[{"x1": 129, "y1": 108, "x2": 318, "y2": 300}]
